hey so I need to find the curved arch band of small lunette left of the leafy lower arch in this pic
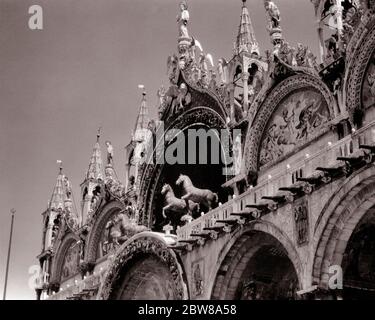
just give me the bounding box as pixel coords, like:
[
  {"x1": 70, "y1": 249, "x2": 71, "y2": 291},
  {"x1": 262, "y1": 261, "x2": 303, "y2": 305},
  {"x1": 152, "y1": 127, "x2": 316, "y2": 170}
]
[{"x1": 85, "y1": 201, "x2": 124, "y2": 264}]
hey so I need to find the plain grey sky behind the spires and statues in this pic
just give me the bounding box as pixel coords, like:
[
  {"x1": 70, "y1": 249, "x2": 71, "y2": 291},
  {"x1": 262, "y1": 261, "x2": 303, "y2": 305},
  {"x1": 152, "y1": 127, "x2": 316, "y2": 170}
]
[{"x1": 0, "y1": 0, "x2": 317, "y2": 299}]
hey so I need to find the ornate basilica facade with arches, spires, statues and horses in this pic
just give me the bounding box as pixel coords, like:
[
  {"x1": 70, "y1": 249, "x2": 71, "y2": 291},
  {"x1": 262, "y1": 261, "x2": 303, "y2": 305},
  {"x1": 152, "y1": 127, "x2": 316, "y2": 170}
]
[{"x1": 36, "y1": 0, "x2": 375, "y2": 300}]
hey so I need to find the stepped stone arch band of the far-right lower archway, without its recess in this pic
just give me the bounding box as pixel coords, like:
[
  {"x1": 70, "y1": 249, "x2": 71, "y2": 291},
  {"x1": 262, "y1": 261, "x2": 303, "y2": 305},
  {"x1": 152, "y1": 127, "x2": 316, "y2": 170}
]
[{"x1": 309, "y1": 166, "x2": 375, "y2": 288}]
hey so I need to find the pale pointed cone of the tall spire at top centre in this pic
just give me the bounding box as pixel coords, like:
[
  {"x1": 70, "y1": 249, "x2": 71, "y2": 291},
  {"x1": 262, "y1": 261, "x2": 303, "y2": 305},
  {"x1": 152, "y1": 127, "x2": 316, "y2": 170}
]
[{"x1": 235, "y1": 0, "x2": 259, "y2": 55}]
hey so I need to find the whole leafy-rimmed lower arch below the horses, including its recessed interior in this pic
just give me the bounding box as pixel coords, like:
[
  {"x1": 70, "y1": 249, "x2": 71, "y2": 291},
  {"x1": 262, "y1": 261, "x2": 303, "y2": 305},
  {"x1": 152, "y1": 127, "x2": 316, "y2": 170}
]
[{"x1": 97, "y1": 232, "x2": 188, "y2": 300}]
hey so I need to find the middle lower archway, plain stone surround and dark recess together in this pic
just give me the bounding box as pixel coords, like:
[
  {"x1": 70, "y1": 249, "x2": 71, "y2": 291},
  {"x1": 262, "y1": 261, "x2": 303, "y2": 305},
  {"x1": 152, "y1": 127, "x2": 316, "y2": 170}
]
[{"x1": 211, "y1": 223, "x2": 302, "y2": 300}]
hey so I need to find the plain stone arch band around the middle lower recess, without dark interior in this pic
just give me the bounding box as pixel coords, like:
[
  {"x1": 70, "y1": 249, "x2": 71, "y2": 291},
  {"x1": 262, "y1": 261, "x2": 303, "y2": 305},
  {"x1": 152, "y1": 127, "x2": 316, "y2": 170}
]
[{"x1": 212, "y1": 220, "x2": 304, "y2": 300}]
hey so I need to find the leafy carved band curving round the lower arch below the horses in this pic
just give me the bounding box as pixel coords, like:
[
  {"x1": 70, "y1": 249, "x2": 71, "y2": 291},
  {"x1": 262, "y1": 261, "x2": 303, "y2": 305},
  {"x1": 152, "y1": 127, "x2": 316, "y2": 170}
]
[{"x1": 99, "y1": 237, "x2": 185, "y2": 300}]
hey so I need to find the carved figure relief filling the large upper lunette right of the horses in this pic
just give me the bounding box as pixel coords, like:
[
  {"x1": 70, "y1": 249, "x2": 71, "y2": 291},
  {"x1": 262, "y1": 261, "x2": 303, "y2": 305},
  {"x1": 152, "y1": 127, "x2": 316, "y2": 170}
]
[{"x1": 259, "y1": 90, "x2": 329, "y2": 166}]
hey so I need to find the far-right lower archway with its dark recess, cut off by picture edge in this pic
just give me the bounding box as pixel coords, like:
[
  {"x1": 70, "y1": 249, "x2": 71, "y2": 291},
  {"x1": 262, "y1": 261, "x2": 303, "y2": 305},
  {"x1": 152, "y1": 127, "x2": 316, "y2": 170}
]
[{"x1": 312, "y1": 166, "x2": 375, "y2": 299}]
